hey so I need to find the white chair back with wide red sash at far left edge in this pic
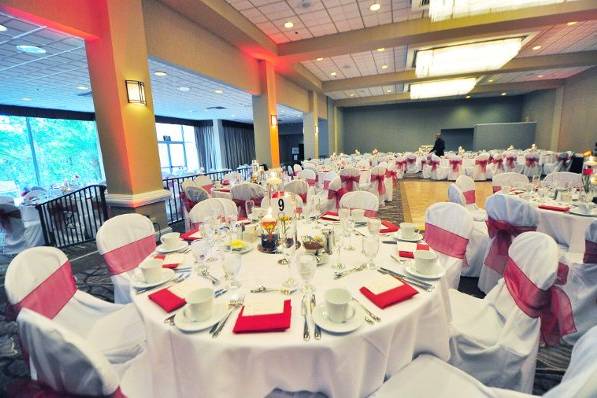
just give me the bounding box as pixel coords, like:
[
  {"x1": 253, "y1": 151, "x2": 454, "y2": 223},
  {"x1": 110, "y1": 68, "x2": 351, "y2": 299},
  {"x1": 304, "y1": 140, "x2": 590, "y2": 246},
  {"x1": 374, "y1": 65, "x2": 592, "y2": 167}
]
[{"x1": 4, "y1": 247, "x2": 77, "y2": 319}]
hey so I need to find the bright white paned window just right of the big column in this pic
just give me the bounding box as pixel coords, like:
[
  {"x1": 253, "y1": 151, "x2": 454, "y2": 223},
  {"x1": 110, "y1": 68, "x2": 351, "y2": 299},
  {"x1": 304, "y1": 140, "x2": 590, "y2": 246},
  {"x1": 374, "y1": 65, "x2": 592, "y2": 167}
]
[{"x1": 156, "y1": 123, "x2": 199, "y2": 176}]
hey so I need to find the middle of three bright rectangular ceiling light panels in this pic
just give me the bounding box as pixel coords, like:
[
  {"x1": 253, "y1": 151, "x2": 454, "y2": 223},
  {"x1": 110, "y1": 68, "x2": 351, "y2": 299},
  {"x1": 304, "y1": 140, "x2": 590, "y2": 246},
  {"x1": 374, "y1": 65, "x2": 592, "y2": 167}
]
[{"x1": 416, "y1": 37, "x2": 522, "y2": 77}]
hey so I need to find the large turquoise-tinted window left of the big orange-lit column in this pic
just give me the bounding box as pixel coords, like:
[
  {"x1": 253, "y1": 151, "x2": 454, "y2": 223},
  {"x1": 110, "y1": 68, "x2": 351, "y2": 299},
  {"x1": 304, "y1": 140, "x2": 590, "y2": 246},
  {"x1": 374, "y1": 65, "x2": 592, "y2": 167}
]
[{"x1": 0, "y1": 115, "x2": 103, "y2": 193}]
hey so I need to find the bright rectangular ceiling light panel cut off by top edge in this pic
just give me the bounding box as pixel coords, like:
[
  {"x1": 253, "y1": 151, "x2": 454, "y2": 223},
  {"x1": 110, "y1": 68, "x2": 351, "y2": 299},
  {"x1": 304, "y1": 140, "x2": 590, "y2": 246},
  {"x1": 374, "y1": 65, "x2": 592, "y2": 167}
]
[{"x1": 429, "y1": 0, "x2": 567, "y2": 21}]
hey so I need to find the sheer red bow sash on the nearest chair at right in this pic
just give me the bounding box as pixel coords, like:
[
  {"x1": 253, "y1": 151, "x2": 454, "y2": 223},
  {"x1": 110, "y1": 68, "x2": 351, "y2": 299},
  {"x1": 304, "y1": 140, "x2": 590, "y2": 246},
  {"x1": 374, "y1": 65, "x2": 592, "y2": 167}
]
[{"x1": 504, "y1": 258, "x2": 576, "y2": 346}]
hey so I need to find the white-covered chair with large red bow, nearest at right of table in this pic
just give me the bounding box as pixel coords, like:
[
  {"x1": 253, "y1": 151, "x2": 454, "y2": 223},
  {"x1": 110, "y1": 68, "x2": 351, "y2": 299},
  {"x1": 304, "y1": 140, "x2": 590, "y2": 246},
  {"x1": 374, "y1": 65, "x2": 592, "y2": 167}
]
[{"x1": 449, "y1": 232, "x2": 558, "y2": 392}]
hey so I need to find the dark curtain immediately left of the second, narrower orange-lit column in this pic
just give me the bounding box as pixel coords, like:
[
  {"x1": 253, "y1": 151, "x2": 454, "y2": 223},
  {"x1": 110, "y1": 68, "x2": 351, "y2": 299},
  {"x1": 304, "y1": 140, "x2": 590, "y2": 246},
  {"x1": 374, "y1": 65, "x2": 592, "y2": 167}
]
[{"x1": 222, "y1": 122, "x2": 255, "y2": 169}]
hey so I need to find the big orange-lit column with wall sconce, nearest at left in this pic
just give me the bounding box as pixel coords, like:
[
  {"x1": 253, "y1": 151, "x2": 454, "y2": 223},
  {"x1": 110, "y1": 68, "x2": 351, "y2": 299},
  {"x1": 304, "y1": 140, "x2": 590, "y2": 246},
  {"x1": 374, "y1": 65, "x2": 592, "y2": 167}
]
[{"x1": 85, "y1": 0, "x2": 170, "y2": 228}]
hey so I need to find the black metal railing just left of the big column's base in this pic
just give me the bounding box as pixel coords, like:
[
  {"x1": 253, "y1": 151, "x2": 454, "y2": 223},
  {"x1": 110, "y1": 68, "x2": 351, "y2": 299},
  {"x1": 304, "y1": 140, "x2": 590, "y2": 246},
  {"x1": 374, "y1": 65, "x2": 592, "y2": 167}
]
[{"x1": 35, "y1": 185, "x2": 108, "y2": 248}]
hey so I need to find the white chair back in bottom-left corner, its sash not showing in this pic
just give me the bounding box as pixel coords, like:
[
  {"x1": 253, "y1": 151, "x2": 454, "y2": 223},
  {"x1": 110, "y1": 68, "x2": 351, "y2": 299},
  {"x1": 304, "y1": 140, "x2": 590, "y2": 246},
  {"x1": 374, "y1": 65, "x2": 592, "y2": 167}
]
[{"x1": 17, "y1": 309, "x2": 119, "y2": 397}]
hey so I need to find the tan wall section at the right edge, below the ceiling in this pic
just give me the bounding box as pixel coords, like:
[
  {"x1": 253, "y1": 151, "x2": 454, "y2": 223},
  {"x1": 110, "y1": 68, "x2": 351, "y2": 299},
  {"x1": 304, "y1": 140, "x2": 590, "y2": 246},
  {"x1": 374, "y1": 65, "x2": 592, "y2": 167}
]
[{"x1": 558, "y1": 67, "x2": 597, "y2": 152}]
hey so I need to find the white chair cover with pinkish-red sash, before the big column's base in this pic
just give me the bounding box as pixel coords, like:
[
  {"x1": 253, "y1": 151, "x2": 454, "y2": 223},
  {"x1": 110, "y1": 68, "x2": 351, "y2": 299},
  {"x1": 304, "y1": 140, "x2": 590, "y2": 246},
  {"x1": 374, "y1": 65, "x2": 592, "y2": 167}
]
[{"x1": 95, "y1": 213, "x2": 156, "y2": 304}]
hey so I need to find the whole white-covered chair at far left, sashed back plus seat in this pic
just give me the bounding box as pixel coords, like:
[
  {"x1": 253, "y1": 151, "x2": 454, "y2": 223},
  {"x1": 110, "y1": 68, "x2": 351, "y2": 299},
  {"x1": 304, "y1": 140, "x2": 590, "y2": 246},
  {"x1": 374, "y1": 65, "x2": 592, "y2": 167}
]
[{"x1": 5, "y1": 247, "x2": 145, "y2": 363}]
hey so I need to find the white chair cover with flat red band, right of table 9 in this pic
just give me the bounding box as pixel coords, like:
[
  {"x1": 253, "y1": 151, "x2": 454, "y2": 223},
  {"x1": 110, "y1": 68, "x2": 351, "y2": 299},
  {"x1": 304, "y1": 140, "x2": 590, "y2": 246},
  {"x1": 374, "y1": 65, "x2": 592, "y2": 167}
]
[{"x1": 425, "y1": 202, "x2": 473, "y2": 289}]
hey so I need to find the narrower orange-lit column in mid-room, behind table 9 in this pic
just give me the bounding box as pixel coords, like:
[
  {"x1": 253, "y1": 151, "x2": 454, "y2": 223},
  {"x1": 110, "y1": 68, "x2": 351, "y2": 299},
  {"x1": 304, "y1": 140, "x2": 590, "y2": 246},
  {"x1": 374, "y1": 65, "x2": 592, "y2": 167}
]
[{"x1": 253, "y1": 61, "x2": 280, "y2": 167}]
